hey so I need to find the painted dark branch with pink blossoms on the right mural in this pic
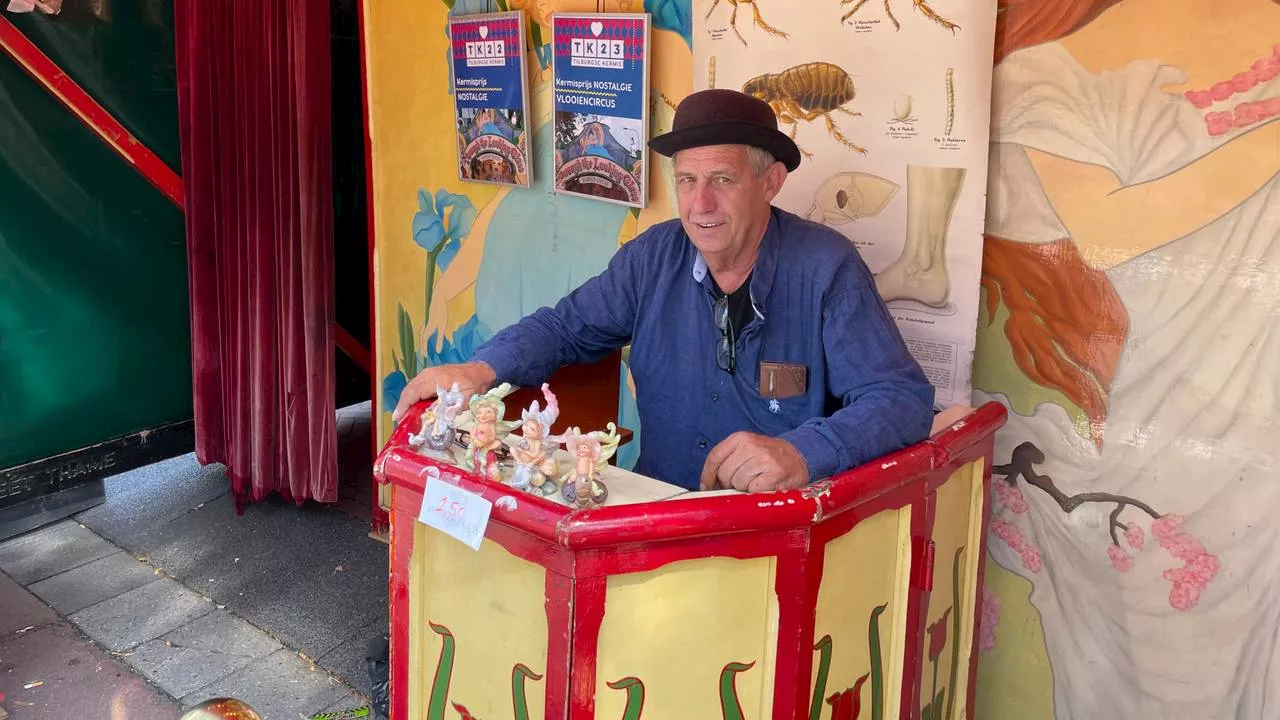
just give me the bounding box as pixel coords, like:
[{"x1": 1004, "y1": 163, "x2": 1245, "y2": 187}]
[{"x1": 991, "y1": 442, "x2": 1221, "y2": 612}]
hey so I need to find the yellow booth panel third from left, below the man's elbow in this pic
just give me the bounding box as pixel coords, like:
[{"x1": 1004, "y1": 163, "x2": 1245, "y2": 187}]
[{"x1": 809, "y1": 507, "x2": 911, "y2": 720}]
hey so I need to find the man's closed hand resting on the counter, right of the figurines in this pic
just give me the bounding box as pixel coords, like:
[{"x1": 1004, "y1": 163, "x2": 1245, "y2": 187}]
[{"x1": 701, "y1": 432, "x2": 809, "y2": 492}]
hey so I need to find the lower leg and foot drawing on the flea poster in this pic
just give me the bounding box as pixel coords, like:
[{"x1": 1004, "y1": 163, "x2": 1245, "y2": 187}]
[{"x1": 876, "y1": 165, "x2": 965, "y2": 307}]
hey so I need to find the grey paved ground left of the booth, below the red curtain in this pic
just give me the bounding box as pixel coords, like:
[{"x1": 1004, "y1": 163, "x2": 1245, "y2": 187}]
[{"x1": 0, "y1": 399, "x2": 388, "y2": 720}]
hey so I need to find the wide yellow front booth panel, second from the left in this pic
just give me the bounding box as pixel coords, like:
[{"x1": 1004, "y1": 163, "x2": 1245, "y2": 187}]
[{"x1": 595, "y1": 557, "x2": 778, "y2": 719}]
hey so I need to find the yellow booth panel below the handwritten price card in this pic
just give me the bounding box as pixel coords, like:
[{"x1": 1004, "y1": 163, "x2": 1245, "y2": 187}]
[{"x1": 408, "y1": 523, "x2": 547, "y2": 720}]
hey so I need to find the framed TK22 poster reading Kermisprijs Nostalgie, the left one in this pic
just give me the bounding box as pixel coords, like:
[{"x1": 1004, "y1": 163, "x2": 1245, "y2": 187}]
[{"x1": 449, "y1": 13, "x2": 531, "y2": 187}]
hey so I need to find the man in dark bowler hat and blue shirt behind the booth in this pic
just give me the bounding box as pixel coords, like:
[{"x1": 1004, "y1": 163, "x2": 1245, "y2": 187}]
[{"x1": 394, "y1": 90, "x2": 933, "y2": 492}]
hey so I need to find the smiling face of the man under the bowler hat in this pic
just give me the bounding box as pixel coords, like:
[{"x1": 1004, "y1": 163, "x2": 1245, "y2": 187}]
[{"x1": 675, "y1": 145, "x2": 786, "y2": 256}]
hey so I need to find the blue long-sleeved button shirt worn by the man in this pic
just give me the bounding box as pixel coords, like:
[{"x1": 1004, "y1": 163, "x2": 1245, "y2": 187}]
[{"x1": 472, "y1": 208, "x2": 933, "y2": 489}]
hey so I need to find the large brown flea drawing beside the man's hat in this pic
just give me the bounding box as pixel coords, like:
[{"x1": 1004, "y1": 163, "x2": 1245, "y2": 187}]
[{"x1": 742, "y1": 61, "x2": 867, "y2": 158}]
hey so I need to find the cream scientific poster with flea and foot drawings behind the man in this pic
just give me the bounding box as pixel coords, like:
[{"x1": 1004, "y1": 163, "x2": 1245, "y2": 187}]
[{"x1": 694, "y1": 0, "x2": 996, "y2": 406}]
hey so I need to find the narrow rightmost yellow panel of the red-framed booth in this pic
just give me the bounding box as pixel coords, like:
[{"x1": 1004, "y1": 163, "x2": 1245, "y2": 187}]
[{"x1": 920, "y1": 460, "x2": 983, "y2": 720}]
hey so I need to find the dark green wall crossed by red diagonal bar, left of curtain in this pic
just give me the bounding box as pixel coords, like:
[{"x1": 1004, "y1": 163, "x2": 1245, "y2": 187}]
[{"x1": 0, "y1": 9, "x2": 191, "y2": 468}]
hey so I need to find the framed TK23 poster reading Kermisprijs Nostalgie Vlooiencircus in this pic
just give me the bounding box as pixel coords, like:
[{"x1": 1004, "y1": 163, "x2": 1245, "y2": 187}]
[{"x1": 552, "y1": 13, "x2": 649, "y2": 208}]
